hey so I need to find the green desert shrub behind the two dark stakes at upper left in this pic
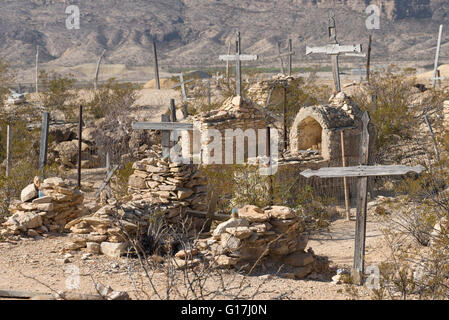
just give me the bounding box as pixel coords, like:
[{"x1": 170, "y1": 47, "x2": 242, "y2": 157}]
[{"x1": 39, "y1": 70, "x2": 76, "y2": 121}]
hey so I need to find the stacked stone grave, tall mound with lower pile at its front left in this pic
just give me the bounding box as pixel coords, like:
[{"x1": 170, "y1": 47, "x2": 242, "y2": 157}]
[{"x1": 65, "y1": 148, "x2": 207, "y2": 258}]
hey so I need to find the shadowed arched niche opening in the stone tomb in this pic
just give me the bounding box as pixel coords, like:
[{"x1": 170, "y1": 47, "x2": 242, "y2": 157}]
[{"x1": 298, "y1": 117, "x2": 323, "y2": 153}]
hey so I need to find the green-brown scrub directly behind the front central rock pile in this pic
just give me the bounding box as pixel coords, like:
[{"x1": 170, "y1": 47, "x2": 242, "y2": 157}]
[{"x1": 201, "y1": 165, "x2": 335, "y2": 230}]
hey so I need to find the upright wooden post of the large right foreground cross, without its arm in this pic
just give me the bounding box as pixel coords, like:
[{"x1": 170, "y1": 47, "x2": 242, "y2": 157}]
[{"x1": 352, "y1": 111, "x2": 371, "y2": 284}]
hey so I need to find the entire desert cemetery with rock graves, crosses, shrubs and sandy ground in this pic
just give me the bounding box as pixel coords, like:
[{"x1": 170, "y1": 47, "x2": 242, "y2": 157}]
[{"x1": 0, "y1": 3, "x2": 449, "y2": 300}]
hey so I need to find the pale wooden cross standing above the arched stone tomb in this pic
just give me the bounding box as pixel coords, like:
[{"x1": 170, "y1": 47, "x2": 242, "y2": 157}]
[{"x1": 306, "y1": 11, "x2": 362, "y2": 92}]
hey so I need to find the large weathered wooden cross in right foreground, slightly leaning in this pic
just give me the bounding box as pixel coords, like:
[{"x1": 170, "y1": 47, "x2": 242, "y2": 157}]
[{"x1": 301, "y1": 112, "x2": 424, "y2": 284}]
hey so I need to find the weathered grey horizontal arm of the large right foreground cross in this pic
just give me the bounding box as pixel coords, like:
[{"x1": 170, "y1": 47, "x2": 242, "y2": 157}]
[{"x1": 301, "y1": 165, "x2": 425, "y2": 178}]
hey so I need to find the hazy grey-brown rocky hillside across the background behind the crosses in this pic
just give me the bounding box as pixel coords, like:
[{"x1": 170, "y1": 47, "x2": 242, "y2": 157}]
[{"x1": 0, "y1": 0, "x2": 449, "y2": 80}]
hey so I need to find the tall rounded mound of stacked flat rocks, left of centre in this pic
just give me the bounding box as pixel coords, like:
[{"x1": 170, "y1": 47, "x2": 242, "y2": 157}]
[{"x1": 128, "y1": 149, "x2": 207, "y2": 223}]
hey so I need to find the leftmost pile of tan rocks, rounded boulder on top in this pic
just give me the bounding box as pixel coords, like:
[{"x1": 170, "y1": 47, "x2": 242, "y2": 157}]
[{"x1": 1, "y1": 177, "x2": 89, "y2": 236}]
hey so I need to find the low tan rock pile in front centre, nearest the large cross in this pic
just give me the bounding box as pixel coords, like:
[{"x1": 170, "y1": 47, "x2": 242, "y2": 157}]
[{"x1": 193, "y1": 205, "x2": 322, "y2": 279}]
